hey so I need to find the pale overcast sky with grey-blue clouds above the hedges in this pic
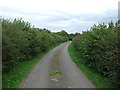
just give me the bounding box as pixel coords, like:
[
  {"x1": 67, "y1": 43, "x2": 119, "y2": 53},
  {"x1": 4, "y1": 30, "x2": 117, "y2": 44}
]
[{"x1": 0, "y1": 0, "x2": 119, "y2": 33}]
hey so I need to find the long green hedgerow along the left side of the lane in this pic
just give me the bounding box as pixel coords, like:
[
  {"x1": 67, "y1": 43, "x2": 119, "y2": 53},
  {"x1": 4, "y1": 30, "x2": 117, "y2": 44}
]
[{"x1": 2, "y1": 18, "x2": 67, "y2": 74}]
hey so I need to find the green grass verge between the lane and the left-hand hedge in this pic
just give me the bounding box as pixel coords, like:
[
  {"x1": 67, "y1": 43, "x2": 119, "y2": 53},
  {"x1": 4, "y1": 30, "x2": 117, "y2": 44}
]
[{"x1": 2, "y1": 44, "x2": 64, "y2": 88}]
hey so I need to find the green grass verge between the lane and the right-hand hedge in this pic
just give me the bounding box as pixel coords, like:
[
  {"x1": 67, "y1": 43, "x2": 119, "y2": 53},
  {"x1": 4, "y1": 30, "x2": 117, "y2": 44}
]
[{"x1": 68, "y1": 43, "x2": 114, "y2": 88}]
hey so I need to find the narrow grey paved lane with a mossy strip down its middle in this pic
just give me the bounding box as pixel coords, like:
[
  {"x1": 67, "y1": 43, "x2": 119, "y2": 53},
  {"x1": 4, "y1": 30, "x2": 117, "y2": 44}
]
[{"x1": 21, "y1": 42, "x2": 95, "y2": 88}]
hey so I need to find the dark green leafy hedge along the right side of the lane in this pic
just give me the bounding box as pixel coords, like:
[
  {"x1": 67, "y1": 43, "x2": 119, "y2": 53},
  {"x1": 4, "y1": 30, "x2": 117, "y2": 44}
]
[{"x1": 73, "y1": 21, "x2": 120, "y2": 86}]
